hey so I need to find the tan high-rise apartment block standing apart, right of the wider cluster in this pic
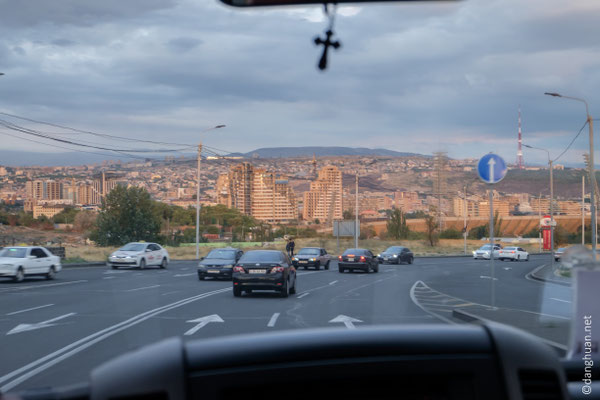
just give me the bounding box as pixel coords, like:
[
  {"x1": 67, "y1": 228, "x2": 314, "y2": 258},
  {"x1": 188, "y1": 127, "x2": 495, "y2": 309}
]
[{"x1": 302, "y1": 166, "x2": 343, "y2": 222}]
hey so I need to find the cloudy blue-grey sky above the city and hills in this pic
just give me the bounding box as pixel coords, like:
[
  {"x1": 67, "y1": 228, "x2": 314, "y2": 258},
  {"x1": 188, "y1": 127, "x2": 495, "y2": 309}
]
[{"x1": 0, "y1": 0, "x2": 600, "y2": 163}]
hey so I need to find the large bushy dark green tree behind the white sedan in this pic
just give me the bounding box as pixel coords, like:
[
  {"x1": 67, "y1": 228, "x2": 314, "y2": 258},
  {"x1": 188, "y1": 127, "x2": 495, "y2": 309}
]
[{"x1": 92, "y1": 186, "x2": 161, "y2": 246}]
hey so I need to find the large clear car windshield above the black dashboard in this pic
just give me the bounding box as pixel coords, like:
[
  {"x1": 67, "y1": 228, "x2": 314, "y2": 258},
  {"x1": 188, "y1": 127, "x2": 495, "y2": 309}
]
[{"x1": 0, "y1": 0, "x2": 600, "y2": 397}]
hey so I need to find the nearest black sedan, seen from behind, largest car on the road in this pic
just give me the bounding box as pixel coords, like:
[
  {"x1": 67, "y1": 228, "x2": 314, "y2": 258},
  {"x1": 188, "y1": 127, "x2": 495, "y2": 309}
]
[{"x1": 233, "y1": 250, "x2": 296, "y2": 297}]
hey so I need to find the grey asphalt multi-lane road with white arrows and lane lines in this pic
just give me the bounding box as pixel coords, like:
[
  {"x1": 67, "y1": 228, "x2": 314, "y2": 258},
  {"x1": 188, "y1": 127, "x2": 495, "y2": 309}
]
[{"x1": 0, "y1": 256, "x2": 572, "y2": 392}]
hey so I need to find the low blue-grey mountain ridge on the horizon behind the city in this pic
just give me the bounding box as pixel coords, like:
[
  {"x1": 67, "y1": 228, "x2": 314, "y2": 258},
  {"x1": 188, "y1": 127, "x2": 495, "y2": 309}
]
[{"x1": 230, "y1": 146, "x2": 430, "y2": 158}]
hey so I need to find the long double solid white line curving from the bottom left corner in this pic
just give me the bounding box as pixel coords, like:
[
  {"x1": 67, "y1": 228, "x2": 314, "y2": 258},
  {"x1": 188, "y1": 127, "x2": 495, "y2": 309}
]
[{"x1": 0, "y1": 288, "x2": 231, "y2": 392}]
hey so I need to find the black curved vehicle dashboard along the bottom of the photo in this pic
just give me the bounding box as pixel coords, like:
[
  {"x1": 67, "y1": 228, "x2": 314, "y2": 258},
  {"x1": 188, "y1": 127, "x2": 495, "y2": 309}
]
[{"x1": 5, "y1": 323, "x2": 593, "y2": 400}]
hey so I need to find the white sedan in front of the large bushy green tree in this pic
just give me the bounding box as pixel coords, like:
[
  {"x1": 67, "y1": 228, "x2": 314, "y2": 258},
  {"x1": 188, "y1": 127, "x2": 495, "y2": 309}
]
[{"x1": 106, "y1": 242, "x2": 170, "y2": 269}]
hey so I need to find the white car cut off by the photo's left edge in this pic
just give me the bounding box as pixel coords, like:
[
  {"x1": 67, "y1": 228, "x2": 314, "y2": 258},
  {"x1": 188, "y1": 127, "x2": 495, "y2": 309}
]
[{"x1": 0, "y1": 246, "x2": 62, "y2": 282}]
